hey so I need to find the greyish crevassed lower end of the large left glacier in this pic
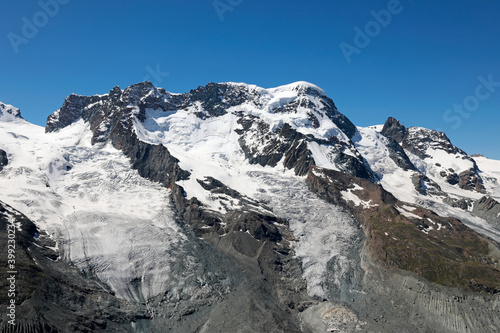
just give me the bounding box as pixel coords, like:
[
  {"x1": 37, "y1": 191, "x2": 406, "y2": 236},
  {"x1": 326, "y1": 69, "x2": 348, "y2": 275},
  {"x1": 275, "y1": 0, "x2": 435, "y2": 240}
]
[{"x1": 57, "y1": 207, "x2": 186, "y2": 302}]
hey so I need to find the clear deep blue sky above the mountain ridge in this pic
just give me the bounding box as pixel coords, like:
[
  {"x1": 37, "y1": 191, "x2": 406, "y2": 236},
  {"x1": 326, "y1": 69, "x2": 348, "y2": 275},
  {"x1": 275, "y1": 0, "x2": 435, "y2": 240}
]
[{"x1": 0, "y1": 0, "x2": 500, "y2": 159}]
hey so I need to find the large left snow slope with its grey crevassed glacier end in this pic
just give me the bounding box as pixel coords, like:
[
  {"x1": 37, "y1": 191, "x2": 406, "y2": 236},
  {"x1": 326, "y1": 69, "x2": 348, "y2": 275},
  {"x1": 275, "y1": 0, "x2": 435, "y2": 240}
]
[{"x1": 0, "y1": 120, "x2": 190, "y2": 302}]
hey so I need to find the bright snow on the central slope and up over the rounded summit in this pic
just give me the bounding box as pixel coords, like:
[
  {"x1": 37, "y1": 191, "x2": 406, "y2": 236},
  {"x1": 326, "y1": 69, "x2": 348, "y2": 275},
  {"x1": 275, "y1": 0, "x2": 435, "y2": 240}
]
[{"x1": 131, "y1": 82, "x2": 356, "y2": 209}]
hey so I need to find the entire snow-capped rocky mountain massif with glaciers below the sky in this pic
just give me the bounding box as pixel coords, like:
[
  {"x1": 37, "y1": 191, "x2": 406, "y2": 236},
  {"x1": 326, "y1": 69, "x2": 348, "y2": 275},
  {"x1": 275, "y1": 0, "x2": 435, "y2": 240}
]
[{"x1": 0, "y1": 82, "x2": 500, "y2": 332}]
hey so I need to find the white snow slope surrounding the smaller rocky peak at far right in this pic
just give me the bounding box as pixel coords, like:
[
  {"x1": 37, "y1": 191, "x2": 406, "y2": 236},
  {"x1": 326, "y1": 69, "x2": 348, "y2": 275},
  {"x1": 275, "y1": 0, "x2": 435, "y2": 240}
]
[{"x1": 353, "y1": 126, "x2": 500, "y2": 241}]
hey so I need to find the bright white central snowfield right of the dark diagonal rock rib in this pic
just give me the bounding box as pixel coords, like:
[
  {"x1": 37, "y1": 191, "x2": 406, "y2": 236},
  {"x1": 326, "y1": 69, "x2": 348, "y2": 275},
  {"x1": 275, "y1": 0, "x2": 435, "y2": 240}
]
[{"x1": 135, "y1": 110, "x2": 262, "y2": 205}]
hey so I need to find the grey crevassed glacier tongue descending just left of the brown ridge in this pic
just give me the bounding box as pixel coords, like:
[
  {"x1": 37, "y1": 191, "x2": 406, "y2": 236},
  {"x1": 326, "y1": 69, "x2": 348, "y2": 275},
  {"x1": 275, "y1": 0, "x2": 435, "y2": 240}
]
[{"x1": 250, "y1": 171, "x2": 363, "y2": 299}]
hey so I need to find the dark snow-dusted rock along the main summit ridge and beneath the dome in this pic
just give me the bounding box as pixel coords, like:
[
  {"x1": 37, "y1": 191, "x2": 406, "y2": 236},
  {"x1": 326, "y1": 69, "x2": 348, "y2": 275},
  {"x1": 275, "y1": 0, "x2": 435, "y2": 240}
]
[{"x1": 46, "y1": 82, "x2": 372, "y2": 178}]
